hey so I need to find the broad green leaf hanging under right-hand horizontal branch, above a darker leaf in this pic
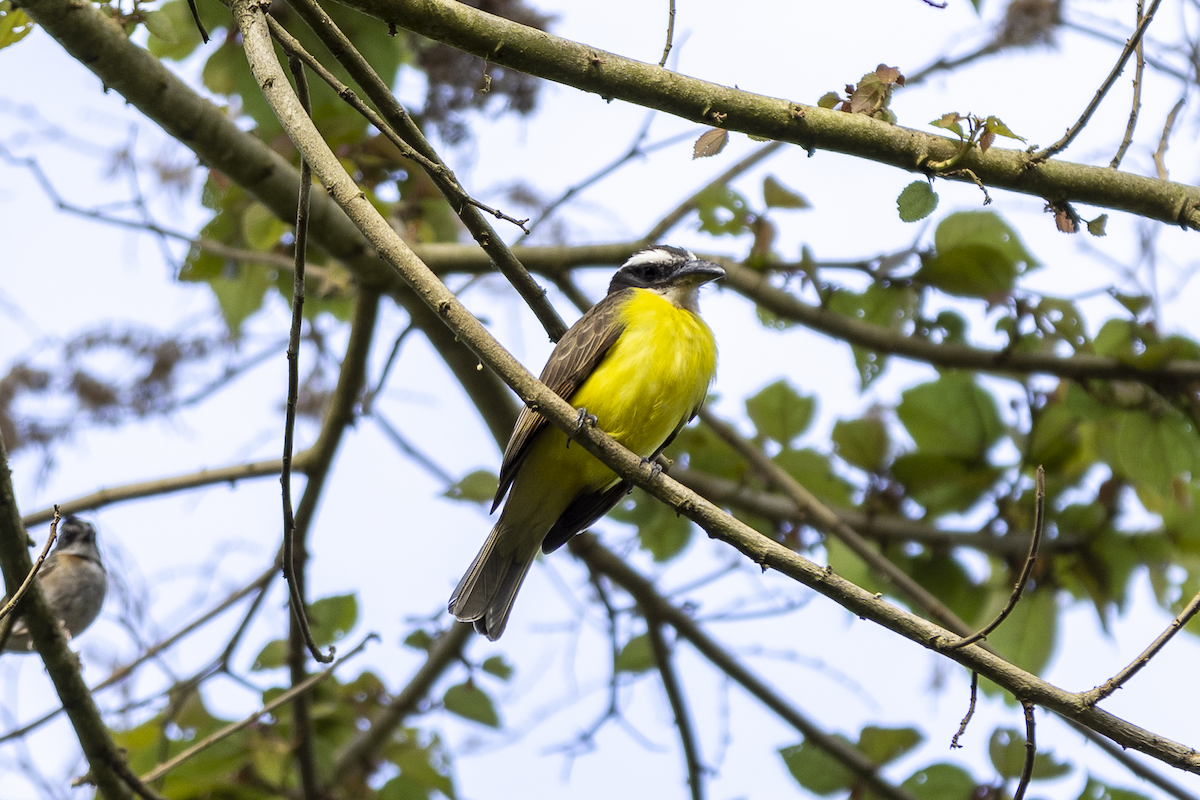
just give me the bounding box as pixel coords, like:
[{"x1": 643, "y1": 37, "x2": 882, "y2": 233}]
[{"x1": 896, "y1": 372, "x2": 1004, "y2": 459}]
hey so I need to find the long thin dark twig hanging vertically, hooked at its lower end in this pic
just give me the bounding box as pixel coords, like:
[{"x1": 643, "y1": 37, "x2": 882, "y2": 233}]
[{"x1": 280, "y1": 53, "x2": 334, "y2": 663}]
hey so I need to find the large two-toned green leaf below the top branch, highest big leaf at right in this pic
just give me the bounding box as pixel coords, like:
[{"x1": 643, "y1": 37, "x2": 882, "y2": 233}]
[{"x1": 916, "y1": 211, "x2": 1040, "y2": 299}]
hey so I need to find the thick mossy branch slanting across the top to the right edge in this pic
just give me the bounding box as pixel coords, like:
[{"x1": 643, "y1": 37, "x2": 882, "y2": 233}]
[{"x1": 344, "y1": 0, "x2": 1200, "y2": 229}]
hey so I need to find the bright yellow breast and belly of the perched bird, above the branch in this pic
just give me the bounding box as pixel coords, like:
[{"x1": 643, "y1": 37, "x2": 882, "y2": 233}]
[{"x1": 570, "y1": 289, "x2": 716, "y2": 470}]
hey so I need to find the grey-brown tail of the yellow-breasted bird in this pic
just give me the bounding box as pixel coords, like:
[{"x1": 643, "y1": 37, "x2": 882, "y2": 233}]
[{"x1": 449, "y1": 521, "x2": 538, "y2": 642}]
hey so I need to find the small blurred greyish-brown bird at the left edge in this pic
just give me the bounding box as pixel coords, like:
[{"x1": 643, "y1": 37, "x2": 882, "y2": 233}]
[{"x1": 0, "y1": 515, "x2": 108, "y2": 652}]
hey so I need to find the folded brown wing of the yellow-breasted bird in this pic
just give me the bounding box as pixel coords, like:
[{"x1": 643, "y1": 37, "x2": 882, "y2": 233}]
[{"x1": 492, "y1": 289, "x2": 632, "y2": 511}]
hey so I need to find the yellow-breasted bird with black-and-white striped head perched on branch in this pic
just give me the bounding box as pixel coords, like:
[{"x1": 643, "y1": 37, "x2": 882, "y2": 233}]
[{"x1": 448, "y1": 245, "x2": 725, "y2": 642}]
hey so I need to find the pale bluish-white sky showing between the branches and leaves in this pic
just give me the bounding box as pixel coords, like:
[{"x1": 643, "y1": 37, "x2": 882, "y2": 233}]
[{"x1": 0, "y1": 0, "x2": 1200, "y2": 800}]
